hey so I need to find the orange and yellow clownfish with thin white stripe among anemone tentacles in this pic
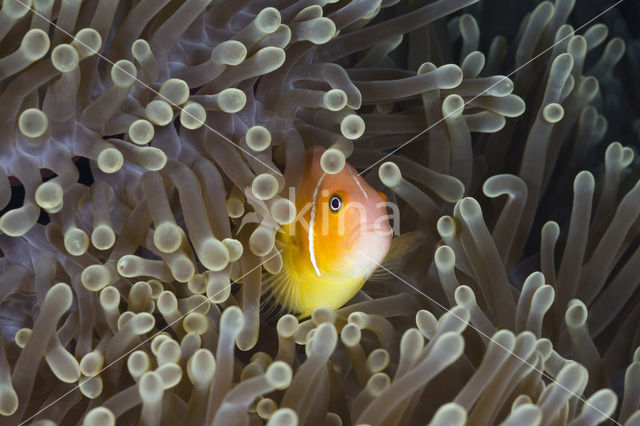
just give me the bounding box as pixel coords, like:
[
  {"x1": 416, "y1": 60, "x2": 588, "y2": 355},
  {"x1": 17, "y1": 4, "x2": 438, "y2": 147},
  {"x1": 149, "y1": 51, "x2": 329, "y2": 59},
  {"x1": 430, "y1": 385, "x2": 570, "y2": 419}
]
[{"x1": 264, "y1": 147, "x2": 416, "y2": 317}]
